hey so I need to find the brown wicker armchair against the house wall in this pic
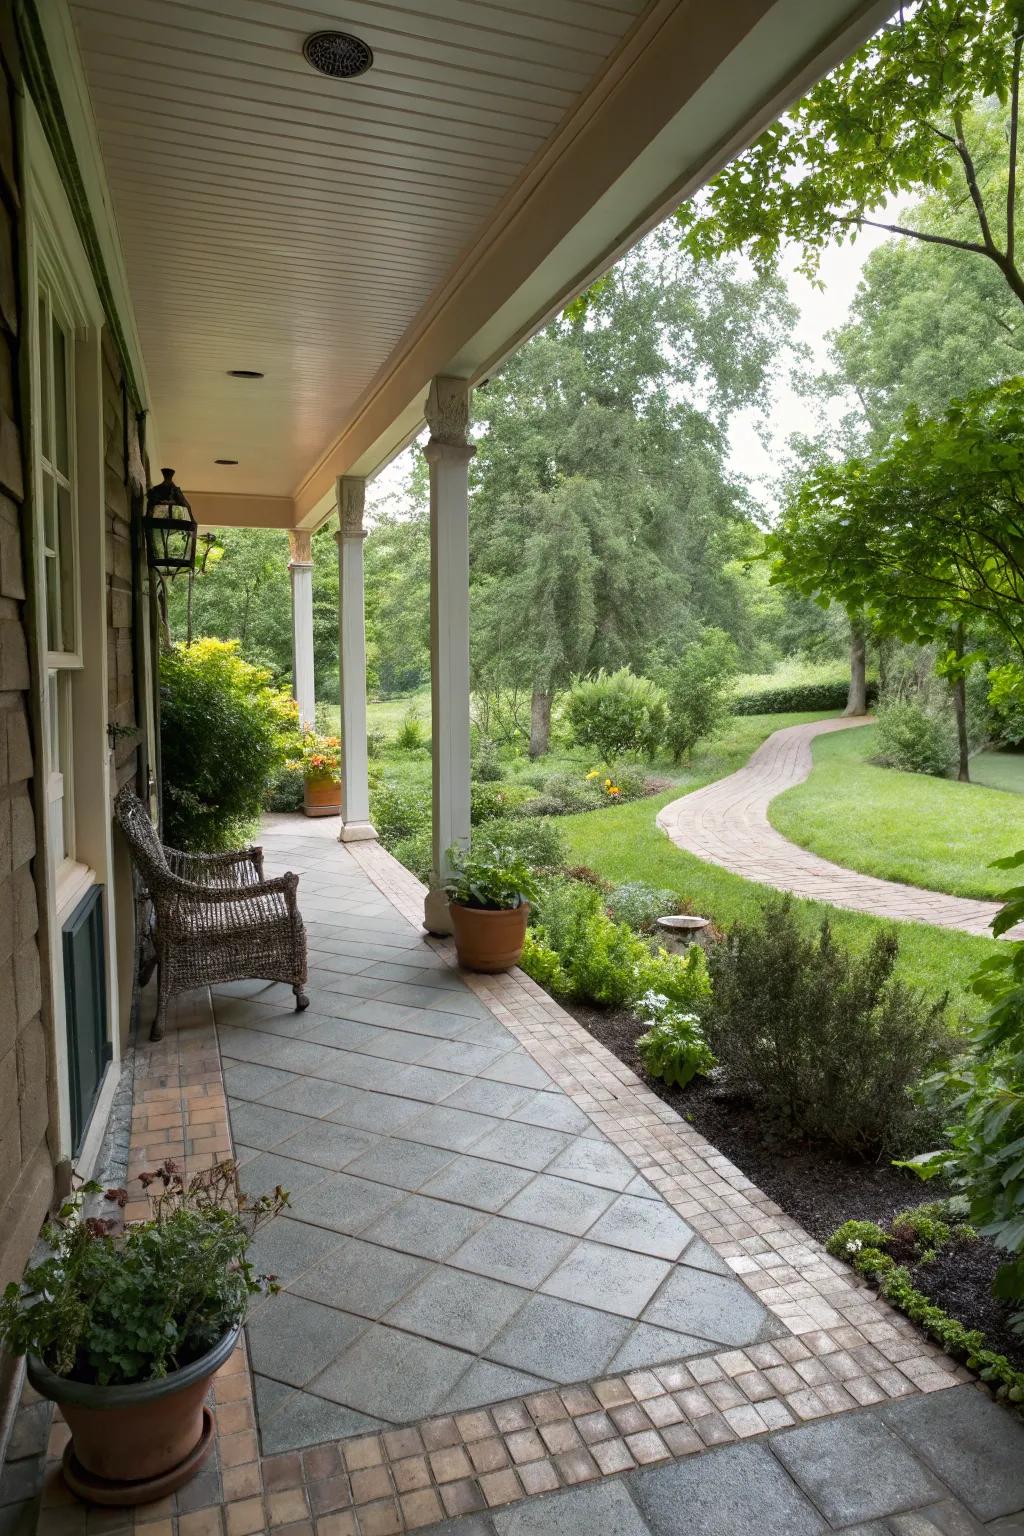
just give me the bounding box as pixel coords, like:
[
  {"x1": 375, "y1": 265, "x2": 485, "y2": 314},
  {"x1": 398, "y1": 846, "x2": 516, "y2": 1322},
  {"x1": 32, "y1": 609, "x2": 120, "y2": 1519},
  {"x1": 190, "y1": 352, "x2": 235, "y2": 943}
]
[{"x1": 114, "y1": 786, "x2": 309, "y2": 1040}]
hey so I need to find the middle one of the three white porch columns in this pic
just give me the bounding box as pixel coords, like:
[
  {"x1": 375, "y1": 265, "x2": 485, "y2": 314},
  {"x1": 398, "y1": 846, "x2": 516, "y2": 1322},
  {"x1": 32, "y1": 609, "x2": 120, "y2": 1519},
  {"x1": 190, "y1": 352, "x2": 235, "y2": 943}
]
[{"x1": 335, "y1": 475, "x2": 376, "y2": 843}]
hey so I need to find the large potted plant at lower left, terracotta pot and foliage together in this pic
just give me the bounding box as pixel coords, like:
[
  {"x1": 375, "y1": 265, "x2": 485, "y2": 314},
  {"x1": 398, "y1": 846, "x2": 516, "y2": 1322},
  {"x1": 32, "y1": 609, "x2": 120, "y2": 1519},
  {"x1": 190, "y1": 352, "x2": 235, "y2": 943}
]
[{"x1": 0, "y1": 1161, "x2": 289, "y2": 1505}]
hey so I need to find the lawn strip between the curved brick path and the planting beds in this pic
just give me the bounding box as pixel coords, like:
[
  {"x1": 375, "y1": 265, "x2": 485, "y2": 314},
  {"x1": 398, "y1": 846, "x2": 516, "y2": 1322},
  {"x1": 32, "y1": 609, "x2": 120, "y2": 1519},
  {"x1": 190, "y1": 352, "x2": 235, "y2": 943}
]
[{"x1": 559, "y1": 714, "x2": 995, "y2": 1015}]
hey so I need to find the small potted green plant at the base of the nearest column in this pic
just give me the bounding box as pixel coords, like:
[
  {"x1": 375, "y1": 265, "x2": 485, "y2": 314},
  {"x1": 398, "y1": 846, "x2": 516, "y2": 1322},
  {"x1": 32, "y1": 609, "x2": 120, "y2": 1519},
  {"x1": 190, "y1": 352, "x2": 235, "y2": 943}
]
[{"x1": 445, "y1": 843, "x2": 537, "y2": 971}]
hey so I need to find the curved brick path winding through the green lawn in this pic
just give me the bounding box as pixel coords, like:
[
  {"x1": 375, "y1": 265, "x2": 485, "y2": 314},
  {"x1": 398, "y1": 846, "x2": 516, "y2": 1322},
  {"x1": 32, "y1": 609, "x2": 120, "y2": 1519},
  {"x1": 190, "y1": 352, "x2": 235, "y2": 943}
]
[{"x1": 657, "y1": 716, "x2": 1021, "y2": 937}]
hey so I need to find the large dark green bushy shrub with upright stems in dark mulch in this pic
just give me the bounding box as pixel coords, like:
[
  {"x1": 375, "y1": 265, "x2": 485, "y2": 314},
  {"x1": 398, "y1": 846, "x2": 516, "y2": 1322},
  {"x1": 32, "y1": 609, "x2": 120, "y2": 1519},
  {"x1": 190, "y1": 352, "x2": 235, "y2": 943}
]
[{"x1": 703, "y1": 897, "x2": 950, "y2": 1155}]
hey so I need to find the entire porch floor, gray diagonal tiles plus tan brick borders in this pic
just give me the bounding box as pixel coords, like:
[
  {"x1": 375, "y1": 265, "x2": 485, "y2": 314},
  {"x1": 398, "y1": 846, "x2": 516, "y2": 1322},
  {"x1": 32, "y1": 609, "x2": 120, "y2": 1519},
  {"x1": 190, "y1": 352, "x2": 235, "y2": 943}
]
[{"x1": 8, "y1": 819, "x2": 1024, "y2": 1536}]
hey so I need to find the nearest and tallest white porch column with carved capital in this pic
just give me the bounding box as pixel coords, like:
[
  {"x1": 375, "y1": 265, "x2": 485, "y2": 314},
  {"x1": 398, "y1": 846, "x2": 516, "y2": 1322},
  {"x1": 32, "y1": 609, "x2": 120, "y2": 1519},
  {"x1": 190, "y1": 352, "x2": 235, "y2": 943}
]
[{"x1": 424, "y1": 378, "x2": 476, "y2": 934}]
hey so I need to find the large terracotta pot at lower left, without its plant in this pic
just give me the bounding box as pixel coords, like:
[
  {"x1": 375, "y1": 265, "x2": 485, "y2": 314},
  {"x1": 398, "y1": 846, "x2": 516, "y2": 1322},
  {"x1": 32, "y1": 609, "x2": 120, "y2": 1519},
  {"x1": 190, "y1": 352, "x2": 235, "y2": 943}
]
[{"x1": 28, "y1": 1322, "x2": 241, "y2": 1504}]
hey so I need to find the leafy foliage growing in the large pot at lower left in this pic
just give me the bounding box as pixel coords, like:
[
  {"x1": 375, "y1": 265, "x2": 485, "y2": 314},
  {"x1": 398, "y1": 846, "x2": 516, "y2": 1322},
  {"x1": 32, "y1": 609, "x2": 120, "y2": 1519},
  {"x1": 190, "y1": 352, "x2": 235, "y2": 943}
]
[{"x1": 0, "y1": 1161, "x2": 289, "y2": 1385}]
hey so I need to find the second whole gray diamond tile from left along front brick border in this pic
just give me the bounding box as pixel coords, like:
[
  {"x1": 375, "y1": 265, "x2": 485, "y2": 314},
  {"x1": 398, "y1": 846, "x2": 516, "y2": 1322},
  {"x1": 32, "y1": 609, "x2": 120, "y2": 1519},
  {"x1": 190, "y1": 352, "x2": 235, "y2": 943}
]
[{"x1": 487, "y1": 1296, "x2": 629, "y2": 1382}]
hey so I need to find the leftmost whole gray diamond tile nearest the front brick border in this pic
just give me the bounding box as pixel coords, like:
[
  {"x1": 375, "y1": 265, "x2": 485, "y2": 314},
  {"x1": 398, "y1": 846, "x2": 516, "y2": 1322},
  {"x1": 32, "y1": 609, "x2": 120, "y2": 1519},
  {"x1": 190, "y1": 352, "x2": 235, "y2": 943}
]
[{"x1": 313, "y1": 1322, "x2": 473, "y2": 1424}]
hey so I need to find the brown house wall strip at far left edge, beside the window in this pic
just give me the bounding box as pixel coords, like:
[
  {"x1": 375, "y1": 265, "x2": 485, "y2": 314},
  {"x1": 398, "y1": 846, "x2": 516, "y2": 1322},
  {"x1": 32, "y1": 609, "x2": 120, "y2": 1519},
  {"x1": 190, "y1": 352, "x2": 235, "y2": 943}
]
[{"x1": 0, "y1": 8, "x2": 54, "y2": 1286}]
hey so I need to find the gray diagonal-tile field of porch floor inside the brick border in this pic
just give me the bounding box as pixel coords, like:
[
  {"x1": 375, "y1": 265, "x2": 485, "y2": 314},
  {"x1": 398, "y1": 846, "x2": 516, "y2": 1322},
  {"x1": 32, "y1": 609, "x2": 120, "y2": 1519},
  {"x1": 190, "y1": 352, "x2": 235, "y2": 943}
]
[{"x1": 222, "y1": 826, "x2": 778, "y2": 1453}]
